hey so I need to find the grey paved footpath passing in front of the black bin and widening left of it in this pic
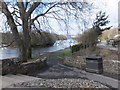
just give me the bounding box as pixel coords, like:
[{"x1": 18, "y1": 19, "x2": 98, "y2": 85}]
[{"x1": 27, "y1": 52, "x2": 120, "y2": 88}]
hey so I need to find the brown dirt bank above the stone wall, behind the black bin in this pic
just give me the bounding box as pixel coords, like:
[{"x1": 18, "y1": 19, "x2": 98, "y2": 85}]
[{"x1": 74, "y1": 48, "x2": 118, "y2": 60}]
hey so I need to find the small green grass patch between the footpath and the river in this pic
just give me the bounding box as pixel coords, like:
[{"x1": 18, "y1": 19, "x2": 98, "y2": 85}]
[{"x1": 52, "y1": 49, "x2": 72, "y2": 58}]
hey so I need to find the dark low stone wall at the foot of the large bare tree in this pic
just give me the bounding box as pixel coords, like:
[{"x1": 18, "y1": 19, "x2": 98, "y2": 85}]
[{"x1": 0, "y1": 57, "x2": 47, "y2": 75}]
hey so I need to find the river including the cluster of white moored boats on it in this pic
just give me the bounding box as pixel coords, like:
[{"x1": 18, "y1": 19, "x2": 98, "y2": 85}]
[{"x1": 0, "y1": 39, "x2": 77, "y2": 60}]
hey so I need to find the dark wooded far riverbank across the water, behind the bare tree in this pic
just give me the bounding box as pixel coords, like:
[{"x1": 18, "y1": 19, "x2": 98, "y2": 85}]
[{"x1": 0, "y1": 30, "x2": 66, "y2": 47}]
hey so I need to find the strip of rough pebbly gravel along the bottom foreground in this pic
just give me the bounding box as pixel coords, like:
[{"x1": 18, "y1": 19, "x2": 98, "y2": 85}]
[{"x1": 13, "y1": 78, "x2": 109, "y2": 89}]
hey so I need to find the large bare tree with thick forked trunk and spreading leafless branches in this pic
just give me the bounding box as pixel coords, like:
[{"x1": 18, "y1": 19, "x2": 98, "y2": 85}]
[{"x1": 0, "y1": 0, "x2": 91, "y2": 62}]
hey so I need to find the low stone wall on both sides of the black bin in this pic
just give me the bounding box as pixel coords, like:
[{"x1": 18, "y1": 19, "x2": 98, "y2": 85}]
[{"x1": 63, "y1": 56, "x2": 120, "y2": 75}]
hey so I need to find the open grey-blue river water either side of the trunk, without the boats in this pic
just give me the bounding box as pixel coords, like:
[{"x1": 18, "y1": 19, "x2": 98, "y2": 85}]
[{"x1": 0, "y1": 41, "x2": 68, "y2": 60}]
